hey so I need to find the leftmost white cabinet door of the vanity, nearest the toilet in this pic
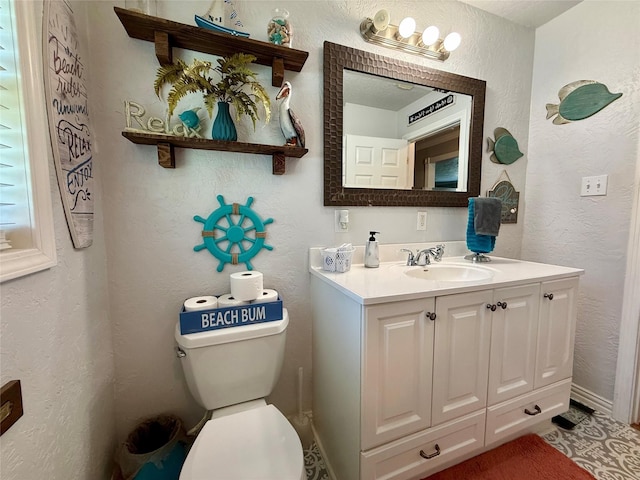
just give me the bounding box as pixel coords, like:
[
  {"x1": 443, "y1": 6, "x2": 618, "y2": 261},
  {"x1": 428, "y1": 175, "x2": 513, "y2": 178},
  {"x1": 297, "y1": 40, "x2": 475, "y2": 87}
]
[{"x1": 362, "y1": 299, "x2": 435, "y2": 450}]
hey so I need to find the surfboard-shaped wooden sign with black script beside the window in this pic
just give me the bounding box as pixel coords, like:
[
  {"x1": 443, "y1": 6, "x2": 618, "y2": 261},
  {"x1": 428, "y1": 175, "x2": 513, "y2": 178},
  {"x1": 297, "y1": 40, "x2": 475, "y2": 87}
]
[{"x1": 42, "y1": 0, "x2": 93, "y2": 248}]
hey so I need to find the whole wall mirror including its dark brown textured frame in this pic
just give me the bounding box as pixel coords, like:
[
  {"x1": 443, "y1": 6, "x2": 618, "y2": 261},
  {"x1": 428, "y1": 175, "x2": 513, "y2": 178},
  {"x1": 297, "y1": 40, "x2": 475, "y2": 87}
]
[{"x1": 324, "y1": 42, "x2": 485, "y2": 207}]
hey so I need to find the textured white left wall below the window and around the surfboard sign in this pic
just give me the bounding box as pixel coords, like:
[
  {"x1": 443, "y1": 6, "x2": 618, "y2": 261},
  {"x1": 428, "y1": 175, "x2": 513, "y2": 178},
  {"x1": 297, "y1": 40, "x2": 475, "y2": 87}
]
[{"x1": 0, "y1": 2, "x2": 116, "y2": 480}]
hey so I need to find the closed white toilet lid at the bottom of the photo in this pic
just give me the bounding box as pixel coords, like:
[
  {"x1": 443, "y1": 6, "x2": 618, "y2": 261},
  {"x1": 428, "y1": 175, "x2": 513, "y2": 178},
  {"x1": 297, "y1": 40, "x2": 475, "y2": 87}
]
[{"x1": 180, "y1": 405, "x2": 304, "y2": 480}]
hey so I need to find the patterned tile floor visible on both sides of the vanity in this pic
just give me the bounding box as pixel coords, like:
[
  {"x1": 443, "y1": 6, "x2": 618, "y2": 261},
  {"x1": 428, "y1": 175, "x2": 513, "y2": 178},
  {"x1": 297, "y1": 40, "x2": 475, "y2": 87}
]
[{"x1": 304, "y1": 407, "x2": 640, "y2": 480}]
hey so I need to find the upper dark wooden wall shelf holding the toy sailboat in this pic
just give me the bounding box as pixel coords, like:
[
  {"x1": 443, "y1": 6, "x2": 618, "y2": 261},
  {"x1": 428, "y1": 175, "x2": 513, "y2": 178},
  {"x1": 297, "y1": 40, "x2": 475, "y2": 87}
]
[{"x1": 113, "y1": 7, "x2": 309, "y2": 87}]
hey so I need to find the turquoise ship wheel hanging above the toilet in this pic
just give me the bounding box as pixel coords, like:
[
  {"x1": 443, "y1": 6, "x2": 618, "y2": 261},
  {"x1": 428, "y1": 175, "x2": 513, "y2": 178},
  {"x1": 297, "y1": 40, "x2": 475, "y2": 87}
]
[{"x1": 193, "y1": 195, "x2": 273, "y2": 272}]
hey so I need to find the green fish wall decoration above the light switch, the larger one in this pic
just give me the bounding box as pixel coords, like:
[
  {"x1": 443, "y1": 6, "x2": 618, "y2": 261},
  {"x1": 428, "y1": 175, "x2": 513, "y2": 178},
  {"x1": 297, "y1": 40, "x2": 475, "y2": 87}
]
[{"x1": 547, "y1": 80, "x2": 622, "y2": 125}]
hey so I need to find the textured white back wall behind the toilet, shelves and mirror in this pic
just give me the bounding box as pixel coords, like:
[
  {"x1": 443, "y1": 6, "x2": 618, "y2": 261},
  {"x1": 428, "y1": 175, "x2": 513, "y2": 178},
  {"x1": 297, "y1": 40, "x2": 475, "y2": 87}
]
[{"x1": 84, "y1": 0, "x2": 534, "y2": 438}]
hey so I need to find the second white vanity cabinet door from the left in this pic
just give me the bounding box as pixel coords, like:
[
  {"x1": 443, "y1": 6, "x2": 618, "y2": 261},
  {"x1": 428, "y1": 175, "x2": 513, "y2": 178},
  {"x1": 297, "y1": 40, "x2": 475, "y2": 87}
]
[{"x1": 431, "y1": 291, "x2": 493, "y2": 425}]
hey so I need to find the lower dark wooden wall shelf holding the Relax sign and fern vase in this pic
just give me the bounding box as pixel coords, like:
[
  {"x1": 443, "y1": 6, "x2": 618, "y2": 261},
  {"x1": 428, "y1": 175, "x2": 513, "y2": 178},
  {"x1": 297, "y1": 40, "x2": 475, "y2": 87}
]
[{"x1": 122, "y1": 130, "x2": 309, "y2": 175}]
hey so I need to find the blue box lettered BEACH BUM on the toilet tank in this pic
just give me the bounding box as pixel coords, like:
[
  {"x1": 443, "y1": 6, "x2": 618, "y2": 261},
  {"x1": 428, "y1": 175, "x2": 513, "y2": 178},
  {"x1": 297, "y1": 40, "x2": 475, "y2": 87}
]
[{"x1": 180, "y1": 296, "x2": 282, "y2": 335}]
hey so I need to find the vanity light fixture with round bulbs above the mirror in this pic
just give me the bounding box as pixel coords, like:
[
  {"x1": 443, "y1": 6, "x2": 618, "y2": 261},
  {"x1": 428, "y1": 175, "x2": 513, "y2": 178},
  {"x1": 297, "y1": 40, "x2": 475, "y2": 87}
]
[{"x1": 360, "y1": 9, "x2": 462, "y2": 61}]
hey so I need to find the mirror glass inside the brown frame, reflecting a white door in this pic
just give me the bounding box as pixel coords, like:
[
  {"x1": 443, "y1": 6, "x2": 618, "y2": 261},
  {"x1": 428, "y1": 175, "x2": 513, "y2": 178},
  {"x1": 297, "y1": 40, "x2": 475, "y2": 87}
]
[{"x1": 342, "y1": 69, "x2": 472, "y2": 192}]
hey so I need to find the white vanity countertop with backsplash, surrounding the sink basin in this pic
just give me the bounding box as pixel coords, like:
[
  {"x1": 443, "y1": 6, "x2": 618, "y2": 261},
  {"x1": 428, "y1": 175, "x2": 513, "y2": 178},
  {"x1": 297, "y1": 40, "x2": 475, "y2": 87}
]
[{"x1": 309, "y1": 244, "x2": 584, "y2": 305}]
